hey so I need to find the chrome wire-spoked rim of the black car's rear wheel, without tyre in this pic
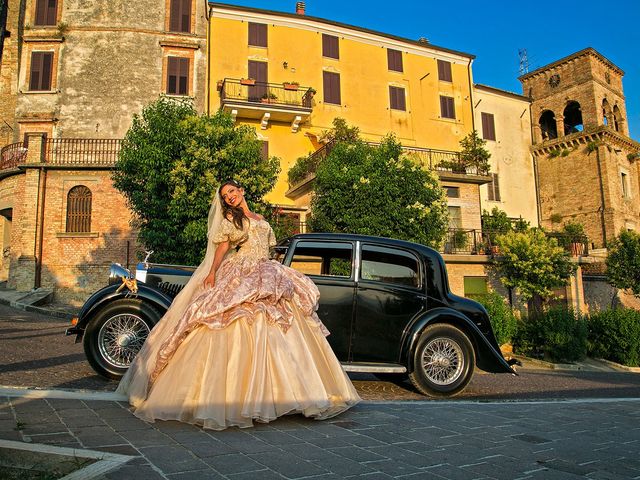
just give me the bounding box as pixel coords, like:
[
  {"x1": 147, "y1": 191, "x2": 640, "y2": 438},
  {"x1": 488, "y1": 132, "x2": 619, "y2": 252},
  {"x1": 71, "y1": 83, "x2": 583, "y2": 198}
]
[{"x1": 422, "y1": 337, "x2": 465, "y2": 385}]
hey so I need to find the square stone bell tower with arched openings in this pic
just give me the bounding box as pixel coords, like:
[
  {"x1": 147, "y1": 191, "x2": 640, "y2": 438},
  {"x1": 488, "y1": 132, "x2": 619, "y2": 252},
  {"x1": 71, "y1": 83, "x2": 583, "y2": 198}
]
[{"x1": 520, "y1": 48, "x2": 640, "y2": 248}]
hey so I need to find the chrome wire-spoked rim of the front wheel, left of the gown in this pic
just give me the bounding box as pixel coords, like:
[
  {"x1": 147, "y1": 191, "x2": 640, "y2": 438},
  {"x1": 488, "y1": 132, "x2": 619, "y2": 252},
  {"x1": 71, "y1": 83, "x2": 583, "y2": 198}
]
[{"x1": 98, "y1": 313, "x2": 150, "y2": 368}]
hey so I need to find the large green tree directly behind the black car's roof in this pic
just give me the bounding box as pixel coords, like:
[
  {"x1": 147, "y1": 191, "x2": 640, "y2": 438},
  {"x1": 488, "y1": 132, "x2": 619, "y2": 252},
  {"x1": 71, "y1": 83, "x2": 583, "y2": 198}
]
[{"x1": 310, "y1": 121, "x2": 448, "y2": 247}]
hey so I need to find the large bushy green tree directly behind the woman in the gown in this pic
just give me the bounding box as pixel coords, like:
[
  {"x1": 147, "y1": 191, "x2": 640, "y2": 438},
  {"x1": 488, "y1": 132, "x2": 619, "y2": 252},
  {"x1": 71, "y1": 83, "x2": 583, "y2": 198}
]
[{"x1": 113, "y1": 97, "x2": 279, "y2": 265}]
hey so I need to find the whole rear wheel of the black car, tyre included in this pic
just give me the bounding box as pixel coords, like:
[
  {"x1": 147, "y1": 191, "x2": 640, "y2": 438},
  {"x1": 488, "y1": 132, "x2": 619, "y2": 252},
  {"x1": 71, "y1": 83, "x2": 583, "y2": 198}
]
[{"x1": 409, "y1": 324, "x2": 475, "y2": 397}]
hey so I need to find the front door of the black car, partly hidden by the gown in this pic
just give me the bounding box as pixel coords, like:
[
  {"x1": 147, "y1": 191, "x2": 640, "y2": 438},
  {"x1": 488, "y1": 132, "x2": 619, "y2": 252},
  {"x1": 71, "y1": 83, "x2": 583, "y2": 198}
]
[{"x1": 285, "y1": 240, "x2": 355, "y2": 361}]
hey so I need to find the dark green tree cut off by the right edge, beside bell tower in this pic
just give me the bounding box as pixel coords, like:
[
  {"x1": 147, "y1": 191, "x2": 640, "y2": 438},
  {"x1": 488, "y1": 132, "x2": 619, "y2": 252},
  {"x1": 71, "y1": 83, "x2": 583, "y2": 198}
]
[{"x1": 606, "y1": 231, "x2": 640, "y2": 297}]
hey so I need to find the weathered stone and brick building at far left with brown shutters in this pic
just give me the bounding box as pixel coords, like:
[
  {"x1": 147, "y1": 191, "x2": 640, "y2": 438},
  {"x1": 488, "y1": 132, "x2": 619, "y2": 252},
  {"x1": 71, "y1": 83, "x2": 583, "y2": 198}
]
[{"x1": 0, "y1": 0, "x2": 207, "y2": 303}]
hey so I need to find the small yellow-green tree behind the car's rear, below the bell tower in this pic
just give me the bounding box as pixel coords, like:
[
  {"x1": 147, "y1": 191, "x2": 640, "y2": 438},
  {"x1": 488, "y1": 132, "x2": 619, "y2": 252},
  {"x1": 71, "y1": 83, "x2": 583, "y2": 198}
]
[{"x1": 494, "y1": 228, "x2": 576, "y2": 310}]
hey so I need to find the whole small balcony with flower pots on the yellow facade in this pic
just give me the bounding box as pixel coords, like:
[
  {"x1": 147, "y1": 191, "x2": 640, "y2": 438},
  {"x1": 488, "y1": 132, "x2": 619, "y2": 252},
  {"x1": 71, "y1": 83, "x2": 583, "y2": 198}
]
[{"x1": 219, "y1": 78, "x2": 315, "y2": 133}]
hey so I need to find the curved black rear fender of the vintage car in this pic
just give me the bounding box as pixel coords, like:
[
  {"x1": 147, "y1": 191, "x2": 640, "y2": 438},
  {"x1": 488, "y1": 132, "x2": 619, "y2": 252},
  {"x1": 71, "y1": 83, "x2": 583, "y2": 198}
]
[{"x1": 401, "y1": 307, "x2": 515, "y2": 374}]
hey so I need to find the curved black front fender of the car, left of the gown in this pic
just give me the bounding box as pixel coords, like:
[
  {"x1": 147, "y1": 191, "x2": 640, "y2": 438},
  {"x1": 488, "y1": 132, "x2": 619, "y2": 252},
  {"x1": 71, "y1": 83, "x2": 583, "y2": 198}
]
[{"x1": 67, "y1": 283, "x2": 172, "y2": 341}]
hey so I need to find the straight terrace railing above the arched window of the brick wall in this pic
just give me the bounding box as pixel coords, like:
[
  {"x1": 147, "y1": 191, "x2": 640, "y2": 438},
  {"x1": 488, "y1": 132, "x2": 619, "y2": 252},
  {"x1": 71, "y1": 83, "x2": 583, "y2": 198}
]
[{"x1": 44, "y1": 138, "x2": 122, "y2": 166}]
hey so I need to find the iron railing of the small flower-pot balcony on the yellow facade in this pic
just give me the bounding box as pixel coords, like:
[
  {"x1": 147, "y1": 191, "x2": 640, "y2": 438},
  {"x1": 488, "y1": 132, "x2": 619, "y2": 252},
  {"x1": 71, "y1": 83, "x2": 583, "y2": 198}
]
[{"x1": 220, "y1": 78, "x2": 315, "y2": 108}]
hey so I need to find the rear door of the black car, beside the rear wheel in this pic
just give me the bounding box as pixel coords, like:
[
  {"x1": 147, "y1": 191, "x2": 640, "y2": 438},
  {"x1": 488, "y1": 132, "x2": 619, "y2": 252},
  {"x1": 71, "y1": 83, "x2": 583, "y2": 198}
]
[{"x1": 351, "y1": 243, "x2": 426, "y2": 363}]
